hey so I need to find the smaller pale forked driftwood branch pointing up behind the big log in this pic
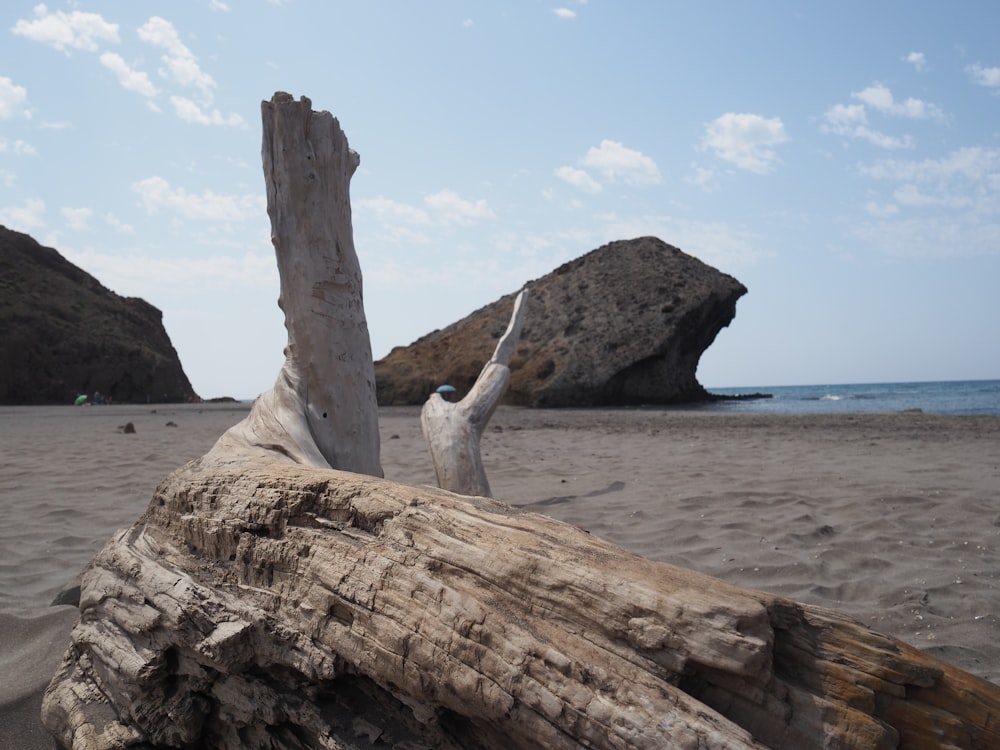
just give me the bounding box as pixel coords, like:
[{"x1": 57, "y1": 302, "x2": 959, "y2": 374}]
[{"x1": 420, "y1": 290, "x2": 528, "y2": 497}]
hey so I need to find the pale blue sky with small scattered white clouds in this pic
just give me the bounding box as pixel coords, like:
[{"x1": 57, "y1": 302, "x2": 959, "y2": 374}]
[{"x1": 0, "y1": 0, "x2": 1000, "y2": 398}]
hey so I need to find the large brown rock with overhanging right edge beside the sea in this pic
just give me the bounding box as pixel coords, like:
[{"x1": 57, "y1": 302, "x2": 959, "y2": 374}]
[{"x1": 375, "y1": 237, "x2": 747, "y2": 407}]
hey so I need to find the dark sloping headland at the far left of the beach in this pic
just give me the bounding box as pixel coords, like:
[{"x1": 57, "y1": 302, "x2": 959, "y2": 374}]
[{"x1": 0, "y1": 226, "x2": 195, "y2": 404}]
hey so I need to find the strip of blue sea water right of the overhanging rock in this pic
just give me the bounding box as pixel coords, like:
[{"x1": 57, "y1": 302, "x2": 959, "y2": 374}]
[{"x1": 701, "y1": 380, "x2": 1000, "y2": 415}]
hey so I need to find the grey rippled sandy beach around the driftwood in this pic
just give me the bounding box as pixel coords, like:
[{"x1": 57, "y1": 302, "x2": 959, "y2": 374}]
[{"x1": 0, "y1": 404, "x2": 1000, "y2": 748}]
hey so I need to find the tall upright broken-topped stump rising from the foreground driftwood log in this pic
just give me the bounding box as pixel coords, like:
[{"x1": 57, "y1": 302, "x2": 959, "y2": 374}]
[{"x1": 223, "y1": 93, "x2": 382, "y2": 476}]
